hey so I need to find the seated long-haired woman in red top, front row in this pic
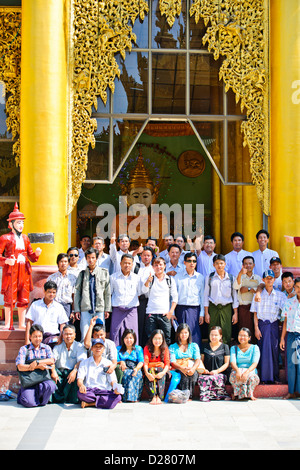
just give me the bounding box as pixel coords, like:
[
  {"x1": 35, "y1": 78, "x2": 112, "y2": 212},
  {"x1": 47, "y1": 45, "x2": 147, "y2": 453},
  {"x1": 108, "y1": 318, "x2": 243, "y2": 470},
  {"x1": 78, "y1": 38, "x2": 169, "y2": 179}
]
[{"x1": 144, "y1": 330, "x2": 170, "y2": 405}]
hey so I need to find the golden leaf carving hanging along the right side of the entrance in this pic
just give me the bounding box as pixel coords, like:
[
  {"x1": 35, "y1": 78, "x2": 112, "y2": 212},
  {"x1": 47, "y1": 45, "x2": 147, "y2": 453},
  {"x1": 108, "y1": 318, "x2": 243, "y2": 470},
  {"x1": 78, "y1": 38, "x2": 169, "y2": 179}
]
[{"x1": 190, "y1": 0, "x2": 270, "y2": 215}]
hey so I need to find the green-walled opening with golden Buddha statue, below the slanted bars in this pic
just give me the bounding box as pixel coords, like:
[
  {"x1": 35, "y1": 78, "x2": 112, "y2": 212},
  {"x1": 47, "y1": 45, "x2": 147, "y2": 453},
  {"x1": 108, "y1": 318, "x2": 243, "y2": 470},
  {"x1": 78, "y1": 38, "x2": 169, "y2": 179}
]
[{"x1": 78, "y1": 122, "x2": 215, "y2": 250}]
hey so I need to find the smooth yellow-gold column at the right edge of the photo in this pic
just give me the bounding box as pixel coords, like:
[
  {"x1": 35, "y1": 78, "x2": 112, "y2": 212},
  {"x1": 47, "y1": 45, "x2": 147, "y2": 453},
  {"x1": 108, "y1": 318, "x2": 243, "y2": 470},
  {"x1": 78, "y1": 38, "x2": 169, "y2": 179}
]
[{"x1": 269, "y1": 0, "x2": 300, "y2": 267}]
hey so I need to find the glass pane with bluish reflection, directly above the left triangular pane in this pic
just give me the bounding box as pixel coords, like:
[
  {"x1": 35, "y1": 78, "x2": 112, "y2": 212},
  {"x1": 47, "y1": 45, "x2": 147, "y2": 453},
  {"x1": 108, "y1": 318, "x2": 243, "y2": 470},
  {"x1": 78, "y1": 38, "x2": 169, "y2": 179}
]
[{"x1": 113, "y1": 52, "x2": 148, "y2": 113}]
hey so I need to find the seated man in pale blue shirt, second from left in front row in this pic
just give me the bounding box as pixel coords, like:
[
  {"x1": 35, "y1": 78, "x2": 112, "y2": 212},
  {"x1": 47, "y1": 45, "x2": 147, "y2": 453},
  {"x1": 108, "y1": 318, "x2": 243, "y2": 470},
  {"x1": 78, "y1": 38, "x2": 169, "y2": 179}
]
[{"x1": 51, "y1": 325, "x2": 87, "y2": 404}]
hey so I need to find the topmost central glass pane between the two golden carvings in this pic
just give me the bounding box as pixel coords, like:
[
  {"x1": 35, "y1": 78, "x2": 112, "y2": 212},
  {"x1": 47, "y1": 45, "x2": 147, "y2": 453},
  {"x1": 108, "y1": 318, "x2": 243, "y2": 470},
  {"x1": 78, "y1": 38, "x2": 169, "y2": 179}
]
[{"x1": 152, "y1": 0, "x2": 186, "y2": 49}]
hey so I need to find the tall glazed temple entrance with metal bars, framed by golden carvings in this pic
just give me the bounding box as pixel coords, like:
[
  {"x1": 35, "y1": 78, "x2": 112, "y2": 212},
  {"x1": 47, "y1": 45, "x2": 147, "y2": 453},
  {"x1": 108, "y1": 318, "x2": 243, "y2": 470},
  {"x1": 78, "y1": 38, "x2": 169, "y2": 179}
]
[{"x1": 77, "y1": 0, "x2": 251, "y2": 253}]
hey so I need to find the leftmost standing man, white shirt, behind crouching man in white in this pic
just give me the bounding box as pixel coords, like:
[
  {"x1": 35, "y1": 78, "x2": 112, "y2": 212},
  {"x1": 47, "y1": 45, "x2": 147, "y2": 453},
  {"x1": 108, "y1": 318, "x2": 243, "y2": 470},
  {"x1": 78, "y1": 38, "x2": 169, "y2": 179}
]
[{"x1": 47, "y1": 253, "x2": 77, "y2": 318}]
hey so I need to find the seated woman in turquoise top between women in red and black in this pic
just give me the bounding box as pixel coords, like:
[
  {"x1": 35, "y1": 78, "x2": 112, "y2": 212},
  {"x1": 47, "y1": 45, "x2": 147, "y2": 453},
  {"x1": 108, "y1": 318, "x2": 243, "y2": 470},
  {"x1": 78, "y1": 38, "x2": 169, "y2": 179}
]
[{"x1": 169, "y1": 323, "x2": 201, "y2": 399}]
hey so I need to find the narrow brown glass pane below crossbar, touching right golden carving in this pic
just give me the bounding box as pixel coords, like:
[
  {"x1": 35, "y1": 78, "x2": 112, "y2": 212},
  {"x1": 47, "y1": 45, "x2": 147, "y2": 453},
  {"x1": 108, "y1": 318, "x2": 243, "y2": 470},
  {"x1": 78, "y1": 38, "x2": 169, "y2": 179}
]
[{"x1": 228, "y1": 121, "x2": 251, "y2": 183}]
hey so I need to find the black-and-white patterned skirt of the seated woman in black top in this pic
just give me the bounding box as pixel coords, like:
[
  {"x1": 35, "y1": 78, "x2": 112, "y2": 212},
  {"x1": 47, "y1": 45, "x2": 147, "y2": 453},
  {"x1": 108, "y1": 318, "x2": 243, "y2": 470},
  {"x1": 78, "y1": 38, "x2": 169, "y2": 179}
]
[{"x1": 198, "y1": 374, "x2": 229, "y2": 401}]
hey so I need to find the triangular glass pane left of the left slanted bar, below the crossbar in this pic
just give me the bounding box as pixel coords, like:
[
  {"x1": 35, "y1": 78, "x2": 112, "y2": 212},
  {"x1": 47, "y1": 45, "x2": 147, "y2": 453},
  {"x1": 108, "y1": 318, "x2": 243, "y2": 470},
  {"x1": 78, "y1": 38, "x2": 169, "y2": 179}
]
[{"x1": 113, "y1": 119, "x2": 144, "y2": 172}]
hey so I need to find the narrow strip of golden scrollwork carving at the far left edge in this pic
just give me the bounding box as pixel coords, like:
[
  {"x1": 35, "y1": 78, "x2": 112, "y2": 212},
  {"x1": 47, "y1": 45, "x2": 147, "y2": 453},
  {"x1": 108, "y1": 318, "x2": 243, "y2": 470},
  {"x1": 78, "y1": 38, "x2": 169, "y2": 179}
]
[{"x1": 0, "y1": 8, "x2": 21, "y2": 165}]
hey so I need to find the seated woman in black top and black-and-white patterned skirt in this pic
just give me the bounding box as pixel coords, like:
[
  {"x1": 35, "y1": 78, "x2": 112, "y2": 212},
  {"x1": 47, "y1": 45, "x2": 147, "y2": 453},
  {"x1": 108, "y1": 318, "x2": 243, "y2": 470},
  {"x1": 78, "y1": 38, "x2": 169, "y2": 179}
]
[{"x1": 198, "y1": 326, "x2": 230, "y2": 401}]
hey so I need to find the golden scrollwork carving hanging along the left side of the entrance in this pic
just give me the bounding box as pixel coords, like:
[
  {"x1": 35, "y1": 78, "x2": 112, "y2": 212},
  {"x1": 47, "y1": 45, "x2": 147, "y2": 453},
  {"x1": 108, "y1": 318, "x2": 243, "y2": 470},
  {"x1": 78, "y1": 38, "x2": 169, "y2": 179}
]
[{"x1": 67, "y1": 0, "x2": 148, "y2": 213}]
